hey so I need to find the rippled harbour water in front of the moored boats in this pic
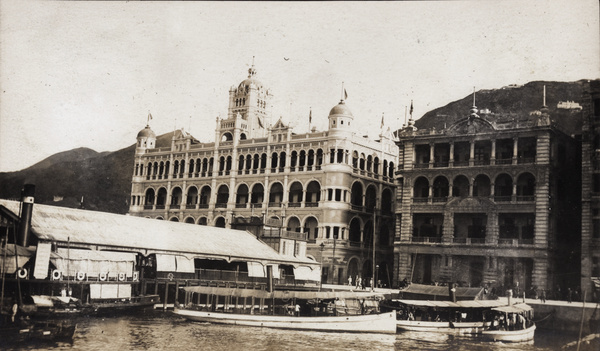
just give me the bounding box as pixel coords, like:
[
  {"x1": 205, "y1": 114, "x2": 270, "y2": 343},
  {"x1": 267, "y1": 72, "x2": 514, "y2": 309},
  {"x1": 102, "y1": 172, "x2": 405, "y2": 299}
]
[{"x1": 0, "y1": 311, "x2": 576, "y2": 351}]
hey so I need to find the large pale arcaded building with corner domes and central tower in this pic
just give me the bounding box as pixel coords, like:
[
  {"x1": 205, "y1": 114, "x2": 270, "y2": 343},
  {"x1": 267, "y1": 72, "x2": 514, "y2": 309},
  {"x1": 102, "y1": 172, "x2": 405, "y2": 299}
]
[{"x1": 129, "y1": 67, "x2": 398, "y2": 285}]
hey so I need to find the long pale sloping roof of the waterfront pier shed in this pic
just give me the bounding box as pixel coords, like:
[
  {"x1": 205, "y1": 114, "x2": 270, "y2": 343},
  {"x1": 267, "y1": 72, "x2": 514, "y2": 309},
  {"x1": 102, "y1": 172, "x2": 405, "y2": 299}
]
[{"x1": 0, "y1": 199, "x2": 316, "y2": 265}]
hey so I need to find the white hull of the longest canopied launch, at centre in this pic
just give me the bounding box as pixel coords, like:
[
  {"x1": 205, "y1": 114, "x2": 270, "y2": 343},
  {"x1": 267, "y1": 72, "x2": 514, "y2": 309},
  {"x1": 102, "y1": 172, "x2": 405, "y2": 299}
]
[{"x1": 174, "y1": 308, "x2": 396, "y2": 334}]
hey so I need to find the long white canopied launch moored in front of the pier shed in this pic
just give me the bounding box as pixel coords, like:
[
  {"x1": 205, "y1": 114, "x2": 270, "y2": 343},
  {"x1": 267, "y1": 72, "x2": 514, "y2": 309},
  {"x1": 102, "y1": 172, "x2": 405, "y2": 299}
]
[{"x1": 174, "y1": 286, "x2": 396, "y2": 334}]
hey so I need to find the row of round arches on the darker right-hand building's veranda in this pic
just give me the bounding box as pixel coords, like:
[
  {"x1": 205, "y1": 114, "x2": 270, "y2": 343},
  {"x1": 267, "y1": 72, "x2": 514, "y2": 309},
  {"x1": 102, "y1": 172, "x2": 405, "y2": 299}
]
[{"x1": 413, "y1": 172, "x2": 536, "y2": 202}]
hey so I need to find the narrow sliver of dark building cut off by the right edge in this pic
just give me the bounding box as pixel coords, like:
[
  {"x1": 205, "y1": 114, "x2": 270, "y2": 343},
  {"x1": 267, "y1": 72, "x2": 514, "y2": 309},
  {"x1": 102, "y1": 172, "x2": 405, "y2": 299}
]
[{"x1": 581, "y1": 80, "x2": 600, "y2": 298}]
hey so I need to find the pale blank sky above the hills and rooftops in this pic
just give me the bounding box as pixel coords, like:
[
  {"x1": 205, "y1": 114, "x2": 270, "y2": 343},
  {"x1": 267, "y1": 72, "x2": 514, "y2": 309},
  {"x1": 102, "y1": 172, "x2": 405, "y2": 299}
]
[{"x1": 0, "y1": 0, "x2": 600, "y2": 171}]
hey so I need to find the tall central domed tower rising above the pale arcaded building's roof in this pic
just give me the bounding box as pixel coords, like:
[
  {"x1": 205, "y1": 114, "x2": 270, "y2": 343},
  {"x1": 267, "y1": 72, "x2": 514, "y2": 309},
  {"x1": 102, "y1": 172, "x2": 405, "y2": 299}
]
[{"x1": 221, "y1": 64, "x2": 273, "y2": 139}]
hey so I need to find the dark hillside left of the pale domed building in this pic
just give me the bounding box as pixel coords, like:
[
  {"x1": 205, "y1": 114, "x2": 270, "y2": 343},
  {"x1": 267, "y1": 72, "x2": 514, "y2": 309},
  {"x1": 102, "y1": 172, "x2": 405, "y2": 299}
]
[{"x1": 0, "y1": 132, "x2": 173, "y2": 213}]
